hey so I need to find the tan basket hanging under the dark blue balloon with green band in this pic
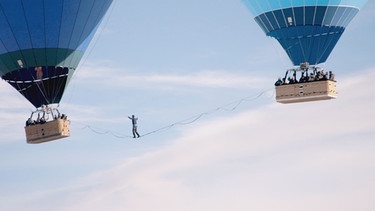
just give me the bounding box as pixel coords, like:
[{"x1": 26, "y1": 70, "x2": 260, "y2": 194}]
[{"x1": 25, "y1": 119, "x2": 70, "y2": 144}]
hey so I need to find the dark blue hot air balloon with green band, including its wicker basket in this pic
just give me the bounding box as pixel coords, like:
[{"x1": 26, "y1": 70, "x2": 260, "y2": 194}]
[{"x1": 0, "y1": 0, "x2": 113, "y2": 143}]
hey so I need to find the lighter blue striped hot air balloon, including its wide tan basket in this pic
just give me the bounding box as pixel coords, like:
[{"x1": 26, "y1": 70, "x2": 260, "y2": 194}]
[{"x1": 242, "y1": 0, "x2": 367, "y2": 103}]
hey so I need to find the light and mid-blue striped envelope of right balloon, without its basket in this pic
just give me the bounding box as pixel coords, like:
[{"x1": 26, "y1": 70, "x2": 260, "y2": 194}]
[{"x1": 242, "y1": 0, "x2": 367, "y2": 65}]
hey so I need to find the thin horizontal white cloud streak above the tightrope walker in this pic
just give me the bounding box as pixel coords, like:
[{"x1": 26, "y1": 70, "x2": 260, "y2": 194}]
[{"x1": 75, "y1": 64, "x2": 269, "y2": 91}]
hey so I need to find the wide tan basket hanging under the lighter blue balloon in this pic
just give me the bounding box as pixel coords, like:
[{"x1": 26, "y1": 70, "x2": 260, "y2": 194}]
[{"x1": 275, "y1": 80, "x2": 337, "y2": 104}]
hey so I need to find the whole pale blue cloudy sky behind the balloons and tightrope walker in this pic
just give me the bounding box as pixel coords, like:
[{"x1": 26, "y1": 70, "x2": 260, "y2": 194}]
[{"x1": 0, "y1": 0, "x2": 375, "y2": 210}]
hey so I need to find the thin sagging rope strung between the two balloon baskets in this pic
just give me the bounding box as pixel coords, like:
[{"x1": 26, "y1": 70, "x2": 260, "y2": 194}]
[{"x1": 74, "y1": 90, "x2": 270, "y2": 139}]
